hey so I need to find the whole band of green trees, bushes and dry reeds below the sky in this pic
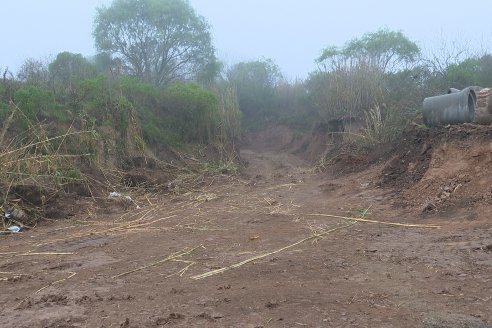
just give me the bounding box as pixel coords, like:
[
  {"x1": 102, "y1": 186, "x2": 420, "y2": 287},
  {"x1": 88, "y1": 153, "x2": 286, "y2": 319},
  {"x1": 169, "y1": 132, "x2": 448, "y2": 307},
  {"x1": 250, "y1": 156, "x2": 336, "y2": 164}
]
[{"x1": 0, "y1": 0, "x2": 492, "y2": 191}]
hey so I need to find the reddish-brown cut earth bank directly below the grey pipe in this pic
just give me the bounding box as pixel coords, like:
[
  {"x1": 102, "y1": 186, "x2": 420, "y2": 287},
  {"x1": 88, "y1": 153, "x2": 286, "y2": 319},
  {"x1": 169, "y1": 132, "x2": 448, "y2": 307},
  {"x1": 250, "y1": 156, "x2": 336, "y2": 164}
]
[{"x1": 380, "y1": 125, "x2": 492, "y2": 213}]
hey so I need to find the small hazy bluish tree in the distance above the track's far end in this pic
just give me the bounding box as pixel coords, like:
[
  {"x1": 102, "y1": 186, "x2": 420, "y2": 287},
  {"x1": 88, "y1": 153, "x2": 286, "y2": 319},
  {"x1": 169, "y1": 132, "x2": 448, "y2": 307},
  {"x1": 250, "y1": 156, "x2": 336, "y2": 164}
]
[{"x1": 226, "y1": 59, "x2": 282, "y2": 123}]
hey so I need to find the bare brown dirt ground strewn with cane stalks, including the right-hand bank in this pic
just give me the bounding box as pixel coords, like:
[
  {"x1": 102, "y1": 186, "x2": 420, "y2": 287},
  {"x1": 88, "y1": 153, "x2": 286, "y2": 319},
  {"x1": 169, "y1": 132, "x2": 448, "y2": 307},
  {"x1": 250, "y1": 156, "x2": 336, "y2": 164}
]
[{"x1": 0, "y1": 127, "x2": 492, "y2": 328}]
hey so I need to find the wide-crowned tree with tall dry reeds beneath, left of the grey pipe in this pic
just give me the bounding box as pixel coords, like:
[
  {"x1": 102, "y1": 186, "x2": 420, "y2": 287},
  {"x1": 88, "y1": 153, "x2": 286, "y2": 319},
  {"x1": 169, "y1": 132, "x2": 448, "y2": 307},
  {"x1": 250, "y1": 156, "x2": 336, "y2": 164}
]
[{"x1": 314, "y1": 29, "x2": 420, "y2": 120}]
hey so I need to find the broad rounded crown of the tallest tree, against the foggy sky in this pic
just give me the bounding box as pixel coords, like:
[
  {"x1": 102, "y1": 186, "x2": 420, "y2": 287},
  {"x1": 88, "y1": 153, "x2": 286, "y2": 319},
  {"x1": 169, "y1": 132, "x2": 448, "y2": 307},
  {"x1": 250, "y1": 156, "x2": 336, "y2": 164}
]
[{"x1": 93, "y1": 0, "x2": 216, "y2": 85}]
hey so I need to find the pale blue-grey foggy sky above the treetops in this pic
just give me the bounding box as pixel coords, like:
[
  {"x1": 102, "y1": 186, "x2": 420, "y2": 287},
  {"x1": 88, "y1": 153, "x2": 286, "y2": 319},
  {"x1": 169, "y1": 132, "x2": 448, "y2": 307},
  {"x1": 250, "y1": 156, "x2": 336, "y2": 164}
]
[{"x1": 0, "y1": 0, "x2": 492, "y2": 79}]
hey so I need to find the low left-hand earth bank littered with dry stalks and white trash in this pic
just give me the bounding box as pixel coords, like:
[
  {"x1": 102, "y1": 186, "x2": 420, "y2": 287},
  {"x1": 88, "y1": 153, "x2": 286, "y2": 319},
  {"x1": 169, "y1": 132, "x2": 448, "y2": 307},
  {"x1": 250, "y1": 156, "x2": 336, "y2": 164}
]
[{"x1": 0, "y1": 142, "x2": 229, "y2": 229}]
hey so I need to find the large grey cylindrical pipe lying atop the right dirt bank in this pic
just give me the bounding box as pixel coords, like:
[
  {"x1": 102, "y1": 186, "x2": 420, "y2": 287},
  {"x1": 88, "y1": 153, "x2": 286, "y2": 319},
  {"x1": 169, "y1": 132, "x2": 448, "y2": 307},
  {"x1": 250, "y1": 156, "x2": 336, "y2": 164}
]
[{"x1": 422, "y1": 87, "x2": 477, "y2": 126}]
